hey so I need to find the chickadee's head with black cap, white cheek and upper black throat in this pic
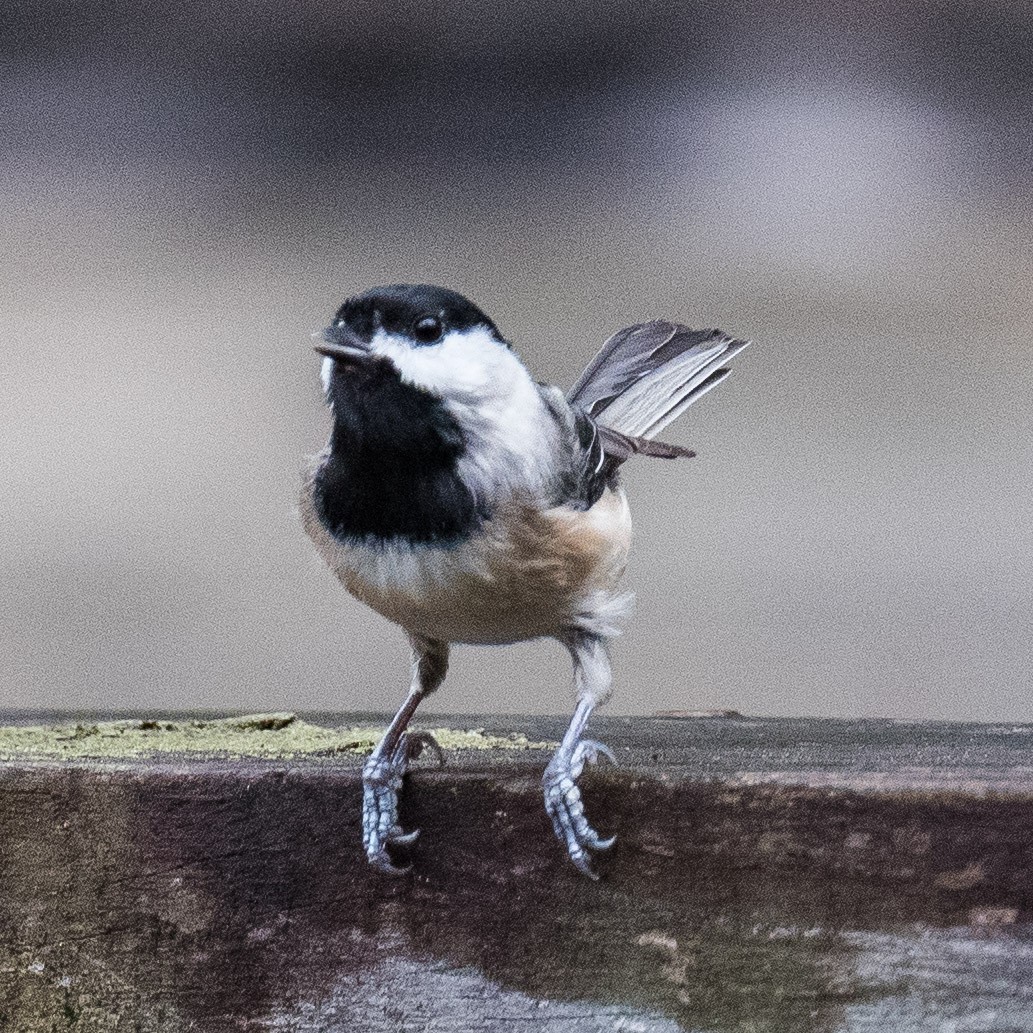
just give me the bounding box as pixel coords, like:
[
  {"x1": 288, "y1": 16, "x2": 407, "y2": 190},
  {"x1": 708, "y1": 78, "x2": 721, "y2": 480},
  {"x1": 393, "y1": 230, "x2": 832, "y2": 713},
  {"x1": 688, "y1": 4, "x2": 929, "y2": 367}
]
[{"x1": 316, "y1": 284, "x2": 558, "y2": 498}]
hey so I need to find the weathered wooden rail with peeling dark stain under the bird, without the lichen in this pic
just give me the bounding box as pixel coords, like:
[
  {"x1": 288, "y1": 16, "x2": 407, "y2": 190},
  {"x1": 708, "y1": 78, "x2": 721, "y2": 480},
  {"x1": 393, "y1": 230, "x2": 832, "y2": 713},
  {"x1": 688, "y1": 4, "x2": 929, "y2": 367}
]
[{"x1": 0, "y1": 718, "x2": 1033, "y2": 1033}]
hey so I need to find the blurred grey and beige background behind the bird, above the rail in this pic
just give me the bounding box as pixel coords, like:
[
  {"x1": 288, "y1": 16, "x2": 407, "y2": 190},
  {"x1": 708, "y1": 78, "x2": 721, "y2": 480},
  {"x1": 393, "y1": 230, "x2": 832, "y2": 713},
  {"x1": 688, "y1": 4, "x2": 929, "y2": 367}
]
[{"x1": 0, "y1": 0, "x2": 1033, "y2": 721}]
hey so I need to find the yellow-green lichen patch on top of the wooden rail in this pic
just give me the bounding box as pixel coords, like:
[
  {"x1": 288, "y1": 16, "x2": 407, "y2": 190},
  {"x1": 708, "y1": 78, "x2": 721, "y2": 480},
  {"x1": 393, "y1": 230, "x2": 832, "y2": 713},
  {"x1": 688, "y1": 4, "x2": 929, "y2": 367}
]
[{"x1": 0, "y1": 714, "x2": 556, "y2": 760}]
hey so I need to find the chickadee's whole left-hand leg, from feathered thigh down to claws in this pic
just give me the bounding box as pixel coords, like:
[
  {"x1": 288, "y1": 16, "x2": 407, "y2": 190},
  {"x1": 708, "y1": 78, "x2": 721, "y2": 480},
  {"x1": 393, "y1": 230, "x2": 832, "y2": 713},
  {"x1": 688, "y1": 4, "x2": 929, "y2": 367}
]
[{"x1": 363, "y1": 635, "x2": 448, "y2": 875}]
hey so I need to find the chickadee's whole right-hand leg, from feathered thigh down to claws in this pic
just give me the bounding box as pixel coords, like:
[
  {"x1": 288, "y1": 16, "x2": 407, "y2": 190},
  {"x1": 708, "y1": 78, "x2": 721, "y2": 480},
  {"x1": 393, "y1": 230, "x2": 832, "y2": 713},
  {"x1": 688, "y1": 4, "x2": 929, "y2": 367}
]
[{"x1": 542, "y1": 634, "x2": 617, "y2": 879}]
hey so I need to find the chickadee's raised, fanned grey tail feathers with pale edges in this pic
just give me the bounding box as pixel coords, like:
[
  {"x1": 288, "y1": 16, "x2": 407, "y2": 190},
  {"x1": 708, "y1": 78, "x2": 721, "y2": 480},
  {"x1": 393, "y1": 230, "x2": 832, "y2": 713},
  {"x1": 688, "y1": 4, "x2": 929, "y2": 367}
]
[{"x1": 567, "y1": 320, "x2": 749, "y2": 438}]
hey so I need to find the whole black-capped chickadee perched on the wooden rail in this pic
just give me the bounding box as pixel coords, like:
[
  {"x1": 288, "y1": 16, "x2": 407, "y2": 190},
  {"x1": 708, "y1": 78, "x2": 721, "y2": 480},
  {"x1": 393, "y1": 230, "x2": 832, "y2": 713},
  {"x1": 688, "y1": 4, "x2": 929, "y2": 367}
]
[{"x1": 300, "y1": 283, "x2": 749, "y2": 879}]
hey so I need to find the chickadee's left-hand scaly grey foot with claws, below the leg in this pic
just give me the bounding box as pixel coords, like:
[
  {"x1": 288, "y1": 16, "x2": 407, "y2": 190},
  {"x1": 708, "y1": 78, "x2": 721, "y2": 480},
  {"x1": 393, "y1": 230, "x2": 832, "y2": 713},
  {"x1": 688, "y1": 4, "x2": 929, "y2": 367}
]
[{"x1": 363, "y1": 731, "x2": 445, "y2": 875}]
